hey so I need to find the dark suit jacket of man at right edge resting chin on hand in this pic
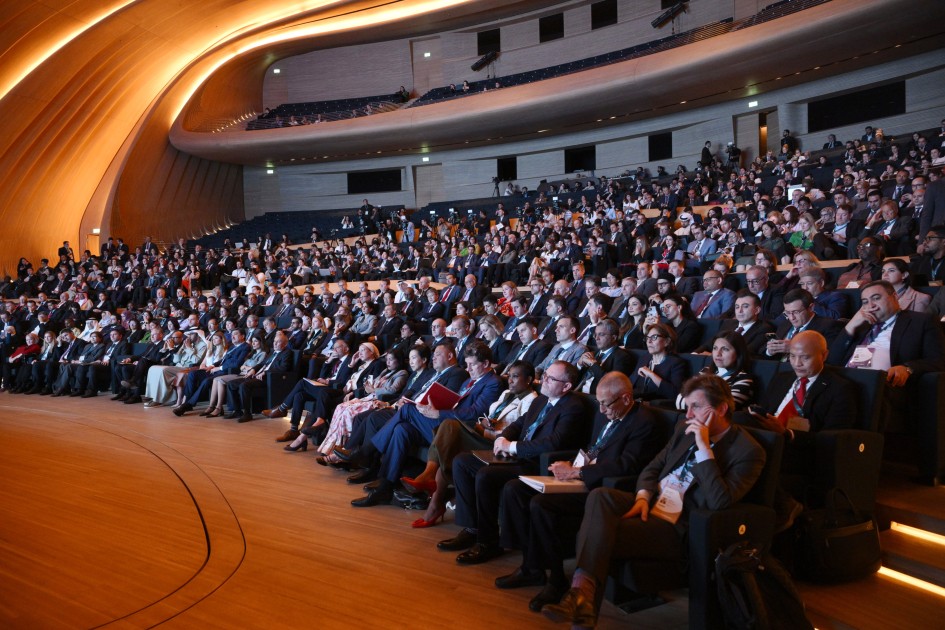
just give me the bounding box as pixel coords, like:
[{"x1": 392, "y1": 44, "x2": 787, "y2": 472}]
[{"x1": 827, "y1": 311, "x2": 945, "y2": 381}]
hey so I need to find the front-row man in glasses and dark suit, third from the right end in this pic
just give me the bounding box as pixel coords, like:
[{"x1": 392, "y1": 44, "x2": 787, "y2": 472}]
[{"x1": 437, "y1": 361, "x2": 590, "y2": 564}]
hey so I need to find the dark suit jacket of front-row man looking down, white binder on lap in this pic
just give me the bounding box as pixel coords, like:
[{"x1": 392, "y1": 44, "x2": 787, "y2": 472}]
[{"x1": 581, "y1": 403, "x2": 669, "y2": 490}]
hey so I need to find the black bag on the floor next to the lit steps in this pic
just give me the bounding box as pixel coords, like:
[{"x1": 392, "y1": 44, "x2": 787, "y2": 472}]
[{"x1": 794, "y1": 488, "x2": 882, "y2": 582}]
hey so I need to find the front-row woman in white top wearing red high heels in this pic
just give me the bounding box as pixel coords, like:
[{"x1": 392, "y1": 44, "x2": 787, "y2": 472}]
[{"x1": 401, "y1": 361, "x2": 538, "y2": 528}]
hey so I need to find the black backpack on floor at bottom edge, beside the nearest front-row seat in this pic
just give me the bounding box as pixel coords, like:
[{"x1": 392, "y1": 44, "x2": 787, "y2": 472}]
[{"x1": 715, "y1": 542, "x2": 814, "y2": 630}]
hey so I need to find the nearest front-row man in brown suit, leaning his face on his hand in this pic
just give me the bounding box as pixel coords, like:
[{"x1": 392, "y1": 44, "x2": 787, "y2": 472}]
[{"x1": 542, "y1": 375, "x2": 765, "y2": 627}]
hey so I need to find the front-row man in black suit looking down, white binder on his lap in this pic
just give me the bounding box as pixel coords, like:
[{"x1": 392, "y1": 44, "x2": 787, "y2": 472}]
[{"x1": 495, "y1": 372, "x2": 666, "y2": 612}]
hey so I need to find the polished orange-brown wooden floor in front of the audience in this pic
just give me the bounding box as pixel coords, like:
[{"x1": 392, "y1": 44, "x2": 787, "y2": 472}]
[{"x1": 0, "y1": 394, "x2": 942, "y2": 629}]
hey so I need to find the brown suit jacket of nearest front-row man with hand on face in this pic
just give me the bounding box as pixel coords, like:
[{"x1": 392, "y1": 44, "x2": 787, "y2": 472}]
[{"x1": 637, "y1": 422, "x2": 766, "y2": 534}]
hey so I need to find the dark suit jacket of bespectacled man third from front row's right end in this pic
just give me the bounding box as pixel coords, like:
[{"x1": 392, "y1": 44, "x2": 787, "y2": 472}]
[{"x1": 502, "y1": 392, "x2": 589, "y2": 459}]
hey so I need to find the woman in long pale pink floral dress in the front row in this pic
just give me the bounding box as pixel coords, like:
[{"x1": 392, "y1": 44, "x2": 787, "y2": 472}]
[{"x1": 285, "y1": 350, "x2": 406, "y2": 466}]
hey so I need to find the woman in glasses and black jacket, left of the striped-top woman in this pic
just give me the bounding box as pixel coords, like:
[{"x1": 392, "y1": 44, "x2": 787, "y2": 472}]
[{"x1": 630, "y1": 323, "x2": 689, "y2": 404}]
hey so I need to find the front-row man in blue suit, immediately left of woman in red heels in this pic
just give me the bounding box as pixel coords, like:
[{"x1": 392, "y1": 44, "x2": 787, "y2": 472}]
[{"x1": 351, "y1": 340, "x2": 502, "y2": 507}]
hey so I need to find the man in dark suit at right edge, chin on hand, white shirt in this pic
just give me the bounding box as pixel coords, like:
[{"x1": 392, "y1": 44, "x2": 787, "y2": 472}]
[{"x1": 827, "y1": 280, "x2": 945, "y2": 386}]
